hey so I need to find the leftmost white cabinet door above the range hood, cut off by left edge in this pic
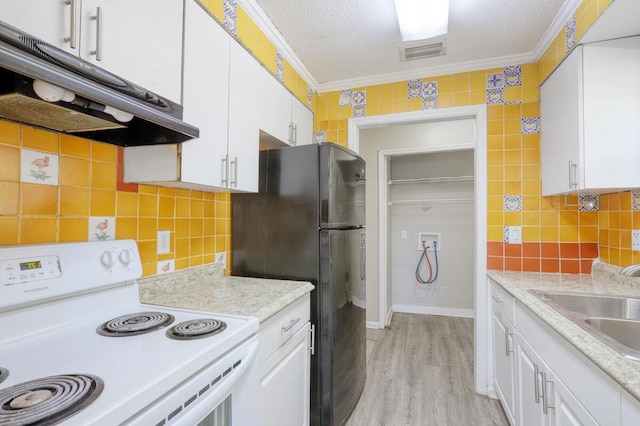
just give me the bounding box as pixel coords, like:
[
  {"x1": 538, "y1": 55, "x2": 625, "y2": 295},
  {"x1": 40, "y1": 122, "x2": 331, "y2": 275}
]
[{"x1": 0, "y1": 0, "x2": 80, "y2": 55}]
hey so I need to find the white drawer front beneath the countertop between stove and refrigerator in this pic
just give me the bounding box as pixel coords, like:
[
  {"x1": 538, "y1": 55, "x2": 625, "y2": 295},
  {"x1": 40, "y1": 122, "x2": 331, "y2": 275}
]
[{"x1": 258, "y1": 293, "x2": 311, "y2": 364}]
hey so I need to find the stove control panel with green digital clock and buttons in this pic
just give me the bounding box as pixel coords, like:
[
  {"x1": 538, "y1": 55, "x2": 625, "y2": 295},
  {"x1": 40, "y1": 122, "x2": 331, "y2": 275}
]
[{"x1": 0, "y1": 256, "x2": 62, "y2": 285}]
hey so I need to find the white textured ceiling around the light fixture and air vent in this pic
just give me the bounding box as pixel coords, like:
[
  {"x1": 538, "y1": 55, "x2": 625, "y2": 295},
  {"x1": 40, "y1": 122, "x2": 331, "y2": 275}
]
[{"x1": 255, "y1": 0, "x2": 576, "y2": 88}]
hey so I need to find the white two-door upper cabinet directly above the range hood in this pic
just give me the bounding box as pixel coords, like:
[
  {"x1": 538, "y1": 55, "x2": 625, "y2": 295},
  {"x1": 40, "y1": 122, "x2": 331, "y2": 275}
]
[{"x1": 0, "y1": 0, "x2": 183, "y2": 103}]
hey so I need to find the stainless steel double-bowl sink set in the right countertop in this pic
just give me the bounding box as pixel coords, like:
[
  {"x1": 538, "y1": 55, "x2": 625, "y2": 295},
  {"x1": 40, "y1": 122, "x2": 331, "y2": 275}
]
[{"x1": 529, "y1": 290, "x2": 640, "y2": 361}]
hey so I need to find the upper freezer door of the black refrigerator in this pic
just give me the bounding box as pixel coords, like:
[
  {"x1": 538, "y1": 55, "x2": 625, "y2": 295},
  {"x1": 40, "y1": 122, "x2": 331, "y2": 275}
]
[{"x1": 319, "y1": 144, "x2": 365, "y2": 229}]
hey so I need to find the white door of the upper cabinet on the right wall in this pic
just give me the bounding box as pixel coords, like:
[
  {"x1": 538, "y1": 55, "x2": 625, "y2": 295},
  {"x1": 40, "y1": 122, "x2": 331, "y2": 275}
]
[{"x1": 540, "y1": 46, "x2": 583, "y2": 195}]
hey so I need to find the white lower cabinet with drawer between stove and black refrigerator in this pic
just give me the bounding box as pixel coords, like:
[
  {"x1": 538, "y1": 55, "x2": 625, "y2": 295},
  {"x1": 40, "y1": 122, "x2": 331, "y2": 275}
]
[{"x1": 258, "y1": 294, "x2": 311, "y2": 426}]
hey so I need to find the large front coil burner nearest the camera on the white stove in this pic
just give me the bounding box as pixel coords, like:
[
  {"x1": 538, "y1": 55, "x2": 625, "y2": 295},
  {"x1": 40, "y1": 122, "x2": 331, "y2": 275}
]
[{"x1": 0, "y1": 374, "x2": 104, "y2": 426}]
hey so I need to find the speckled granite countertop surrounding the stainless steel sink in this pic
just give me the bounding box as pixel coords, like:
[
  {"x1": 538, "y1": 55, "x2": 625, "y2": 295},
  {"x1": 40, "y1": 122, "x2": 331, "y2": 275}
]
[{"x1": 488, "y1": 263, "x2": 640, "y2": 400}]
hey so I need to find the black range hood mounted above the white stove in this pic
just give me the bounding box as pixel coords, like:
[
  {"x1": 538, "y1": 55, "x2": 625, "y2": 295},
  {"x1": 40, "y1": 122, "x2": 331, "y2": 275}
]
[{"x1": 0, "y1": 21, "x2": 199, "y2": 146}]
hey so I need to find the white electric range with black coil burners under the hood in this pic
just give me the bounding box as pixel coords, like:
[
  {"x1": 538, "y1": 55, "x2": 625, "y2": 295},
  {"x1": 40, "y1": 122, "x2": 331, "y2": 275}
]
[{"x1": 0, "y1": 240, "x2": 258, "y2": 426}]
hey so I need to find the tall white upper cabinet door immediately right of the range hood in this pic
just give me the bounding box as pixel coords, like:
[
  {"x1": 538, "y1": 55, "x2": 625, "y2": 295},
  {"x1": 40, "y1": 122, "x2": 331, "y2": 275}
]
[{"x1": 181, "y1": 0, "x2": 230, "y2": 187}]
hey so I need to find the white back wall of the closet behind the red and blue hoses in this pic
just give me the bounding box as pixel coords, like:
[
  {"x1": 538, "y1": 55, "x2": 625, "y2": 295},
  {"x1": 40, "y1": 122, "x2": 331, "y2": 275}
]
[{"x1": 388, "y1": 150, "x2": 475, "y2": 317}]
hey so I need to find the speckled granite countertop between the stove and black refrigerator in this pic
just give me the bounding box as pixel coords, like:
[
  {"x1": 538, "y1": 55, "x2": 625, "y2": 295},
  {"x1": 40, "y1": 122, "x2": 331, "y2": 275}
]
[{"x1": 138, "y1": 263, "x2": 314, "y2": 322}]
